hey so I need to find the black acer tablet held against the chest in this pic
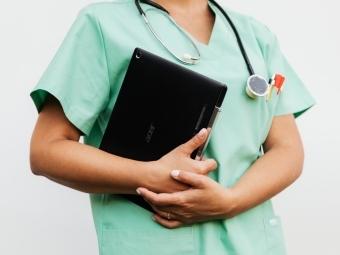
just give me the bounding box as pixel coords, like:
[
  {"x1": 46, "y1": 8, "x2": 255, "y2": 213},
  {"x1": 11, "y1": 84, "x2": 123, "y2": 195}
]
[{"x1": 99, "y1": 48, "x2": 227, "y2": 211}]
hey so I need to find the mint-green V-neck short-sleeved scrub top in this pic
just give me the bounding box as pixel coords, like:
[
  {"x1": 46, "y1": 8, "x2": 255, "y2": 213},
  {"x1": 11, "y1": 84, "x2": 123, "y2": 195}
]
[{"x1": 31, "y1": 0, "x2": 314, "y2": 255}]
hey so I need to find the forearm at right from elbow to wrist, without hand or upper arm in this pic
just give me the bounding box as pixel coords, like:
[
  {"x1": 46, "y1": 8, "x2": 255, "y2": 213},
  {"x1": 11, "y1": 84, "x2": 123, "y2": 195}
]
[{"x1": 228, "y1": 141, "x2": 304, "y2": 217}]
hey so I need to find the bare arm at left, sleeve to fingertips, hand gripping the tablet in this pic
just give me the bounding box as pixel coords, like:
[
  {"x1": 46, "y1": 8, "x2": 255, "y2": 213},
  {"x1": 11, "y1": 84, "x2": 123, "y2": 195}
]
[{"x1": 30, "y1": 96, "x2": 216, "y2": 194}]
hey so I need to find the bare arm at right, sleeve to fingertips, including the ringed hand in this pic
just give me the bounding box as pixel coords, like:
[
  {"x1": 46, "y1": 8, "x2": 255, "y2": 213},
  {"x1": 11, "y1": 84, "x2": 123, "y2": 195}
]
[{"x1": 138, "y1": 115, "x2": 304, "y2": 228}]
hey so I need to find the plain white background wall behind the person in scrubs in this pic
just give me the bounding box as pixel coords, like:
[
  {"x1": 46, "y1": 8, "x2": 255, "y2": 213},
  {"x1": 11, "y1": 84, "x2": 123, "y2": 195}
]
[{"x1": 0, "y1": 0, "x2": 340, "y2": 255}]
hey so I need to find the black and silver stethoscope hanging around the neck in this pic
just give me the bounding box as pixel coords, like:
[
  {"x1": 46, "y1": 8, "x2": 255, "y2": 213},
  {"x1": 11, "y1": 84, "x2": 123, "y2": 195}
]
[{"x1": 135, "y1": 0, "x2": 269, "y2": 98}]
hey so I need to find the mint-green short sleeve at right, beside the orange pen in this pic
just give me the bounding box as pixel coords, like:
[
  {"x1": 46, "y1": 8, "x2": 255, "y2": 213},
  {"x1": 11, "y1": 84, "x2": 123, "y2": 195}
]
[{"x1": 267, "y1": 32, "x2": 315, "y2": 118}]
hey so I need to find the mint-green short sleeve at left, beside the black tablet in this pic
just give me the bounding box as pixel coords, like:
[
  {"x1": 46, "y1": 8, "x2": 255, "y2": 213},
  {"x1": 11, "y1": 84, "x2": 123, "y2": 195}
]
[{"x1": 31, "y1": 5, "x2": 110, "y2": 135}]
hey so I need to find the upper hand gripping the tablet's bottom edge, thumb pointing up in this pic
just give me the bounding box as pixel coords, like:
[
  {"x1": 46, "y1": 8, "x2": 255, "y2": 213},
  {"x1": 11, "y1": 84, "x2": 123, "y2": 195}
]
[{"x1": 144, "y1": 129, "x2": 217, "y2": 193}]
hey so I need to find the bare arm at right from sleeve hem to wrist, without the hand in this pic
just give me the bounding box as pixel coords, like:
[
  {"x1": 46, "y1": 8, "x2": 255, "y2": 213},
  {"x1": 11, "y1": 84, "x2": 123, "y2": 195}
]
[{"x1": 224, "y1": 114, "x2": 304, "y2": 218}]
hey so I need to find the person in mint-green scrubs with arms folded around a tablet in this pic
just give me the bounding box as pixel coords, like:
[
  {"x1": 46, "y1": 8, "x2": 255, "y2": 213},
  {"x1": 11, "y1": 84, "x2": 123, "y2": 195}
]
[{"x1": 30, "y1": 0, "x2": 315, "y2": 255}]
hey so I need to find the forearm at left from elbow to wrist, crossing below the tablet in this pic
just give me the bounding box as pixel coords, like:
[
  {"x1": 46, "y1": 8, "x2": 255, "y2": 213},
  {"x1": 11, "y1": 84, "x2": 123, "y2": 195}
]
[{"x1": 31, "y1": 140, "x2": 171, "y2": 194}]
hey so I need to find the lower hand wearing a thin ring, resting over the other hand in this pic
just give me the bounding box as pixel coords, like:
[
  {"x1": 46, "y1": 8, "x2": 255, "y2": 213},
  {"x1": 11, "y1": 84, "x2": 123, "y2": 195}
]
[{"x1": 137, "y1": 170, "x2": 235, "y2": 228}]
